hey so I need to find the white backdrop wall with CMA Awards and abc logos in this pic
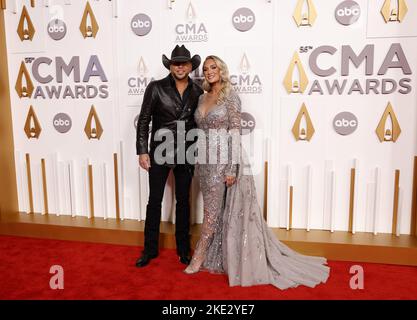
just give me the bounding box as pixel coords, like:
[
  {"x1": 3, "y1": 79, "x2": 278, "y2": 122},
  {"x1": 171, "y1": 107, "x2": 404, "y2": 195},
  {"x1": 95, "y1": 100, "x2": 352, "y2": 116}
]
[{"x1": 5, "y1": 0, "x2": 417, "y2": 234}]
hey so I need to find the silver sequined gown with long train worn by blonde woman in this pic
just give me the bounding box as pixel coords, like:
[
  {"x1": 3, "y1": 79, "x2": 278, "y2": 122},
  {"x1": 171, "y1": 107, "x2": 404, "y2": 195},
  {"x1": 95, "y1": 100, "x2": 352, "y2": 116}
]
[{"x1": 191, "y1": 91, "x2": 330, "y2": 289}]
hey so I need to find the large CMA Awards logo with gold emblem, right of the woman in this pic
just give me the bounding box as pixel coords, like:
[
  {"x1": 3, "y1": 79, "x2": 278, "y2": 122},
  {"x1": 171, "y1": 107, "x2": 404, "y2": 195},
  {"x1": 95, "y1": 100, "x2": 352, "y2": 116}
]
[{"x1": 284, "y1": 43, "x2": 413, "y2": 95}]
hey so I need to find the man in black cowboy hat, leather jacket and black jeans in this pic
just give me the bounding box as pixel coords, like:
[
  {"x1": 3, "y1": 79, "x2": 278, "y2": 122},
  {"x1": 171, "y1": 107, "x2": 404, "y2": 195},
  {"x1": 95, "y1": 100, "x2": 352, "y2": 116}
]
[{"x1": 136, "y1": 45, "x2": 203, "y2": 267}]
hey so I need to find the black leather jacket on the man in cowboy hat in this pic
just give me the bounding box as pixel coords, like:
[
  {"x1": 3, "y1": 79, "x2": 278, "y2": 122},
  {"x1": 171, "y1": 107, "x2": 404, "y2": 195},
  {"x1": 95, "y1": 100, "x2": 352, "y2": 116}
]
[{"x1": 136, "y1": 74, "x2": 203, "y2": 165}]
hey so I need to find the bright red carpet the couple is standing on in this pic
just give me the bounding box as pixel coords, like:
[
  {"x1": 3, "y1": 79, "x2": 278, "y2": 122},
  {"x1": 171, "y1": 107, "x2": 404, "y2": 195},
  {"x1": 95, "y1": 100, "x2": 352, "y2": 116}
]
[{"x1": 0, "y1": 236, "x2": 417, "y2": 300}]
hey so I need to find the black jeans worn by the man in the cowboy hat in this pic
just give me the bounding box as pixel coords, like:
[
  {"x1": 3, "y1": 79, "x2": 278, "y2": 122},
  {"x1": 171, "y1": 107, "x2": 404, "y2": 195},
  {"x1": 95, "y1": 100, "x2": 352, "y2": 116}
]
[{"x1": 144, "y1": 161, "x2": 193, "y2": 256}]
